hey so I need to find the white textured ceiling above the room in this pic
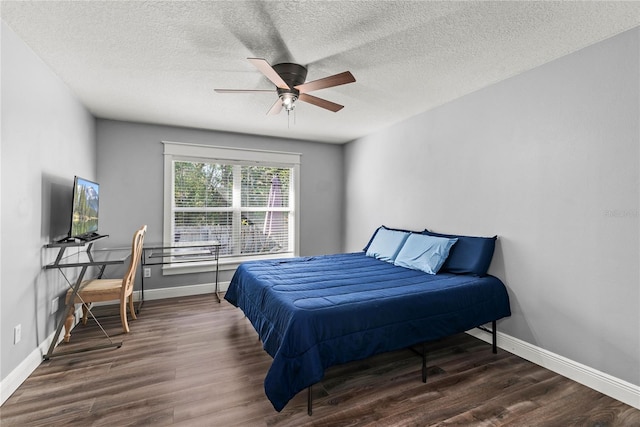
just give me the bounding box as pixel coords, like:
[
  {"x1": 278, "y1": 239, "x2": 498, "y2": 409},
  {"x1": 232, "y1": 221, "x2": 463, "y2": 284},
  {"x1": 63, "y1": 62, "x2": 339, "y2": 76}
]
[{"x1": 0, "y1": 1, "x2": 640, "y2": 143}]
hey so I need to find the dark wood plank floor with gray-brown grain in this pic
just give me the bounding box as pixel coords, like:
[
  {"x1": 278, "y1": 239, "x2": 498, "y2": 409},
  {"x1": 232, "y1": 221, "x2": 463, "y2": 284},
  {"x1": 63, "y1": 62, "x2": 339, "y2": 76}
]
[{"x1": 0, "y1": 295, "x2": 640, "y2": 427}]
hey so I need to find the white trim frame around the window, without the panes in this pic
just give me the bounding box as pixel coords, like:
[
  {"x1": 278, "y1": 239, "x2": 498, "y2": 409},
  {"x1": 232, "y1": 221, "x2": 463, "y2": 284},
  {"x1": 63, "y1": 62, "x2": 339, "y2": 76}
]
[{"x1": 162, "y1": 141, "x2": 302, "y2": 275}]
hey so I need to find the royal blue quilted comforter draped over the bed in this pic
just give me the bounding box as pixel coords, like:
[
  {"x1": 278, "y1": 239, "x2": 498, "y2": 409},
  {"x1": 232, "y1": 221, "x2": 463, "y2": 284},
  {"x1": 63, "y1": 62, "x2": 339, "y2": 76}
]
[{"x1": 225, "y1": 252, "x2": 511, "y2": 411}]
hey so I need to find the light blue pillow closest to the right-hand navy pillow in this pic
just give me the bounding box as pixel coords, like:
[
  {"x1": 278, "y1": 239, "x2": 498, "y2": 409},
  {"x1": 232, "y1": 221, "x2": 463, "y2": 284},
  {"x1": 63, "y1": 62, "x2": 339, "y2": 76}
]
[{"x1": 394, "y1": 234, "x2": 458, "y2": 274}]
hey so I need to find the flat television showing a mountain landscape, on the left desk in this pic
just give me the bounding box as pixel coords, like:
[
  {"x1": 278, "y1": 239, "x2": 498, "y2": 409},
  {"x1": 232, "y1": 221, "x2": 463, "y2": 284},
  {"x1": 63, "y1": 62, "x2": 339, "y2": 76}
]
[{"x1": 69, "y1": 176, "x2": 100, "y2": 238}]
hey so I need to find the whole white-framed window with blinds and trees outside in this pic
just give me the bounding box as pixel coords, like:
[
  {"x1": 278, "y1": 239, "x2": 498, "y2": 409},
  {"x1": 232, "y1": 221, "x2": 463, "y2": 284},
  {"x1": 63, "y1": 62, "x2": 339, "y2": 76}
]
[{"x1": 164, "y1": 142, "x2": 300, "y2": 270}]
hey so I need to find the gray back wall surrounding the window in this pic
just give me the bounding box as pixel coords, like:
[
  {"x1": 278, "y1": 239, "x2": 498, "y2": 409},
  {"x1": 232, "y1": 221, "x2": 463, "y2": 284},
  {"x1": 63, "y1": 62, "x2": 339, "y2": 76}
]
[{"x1": 97, "y1": 120, "x2": 343, "y2": 289}]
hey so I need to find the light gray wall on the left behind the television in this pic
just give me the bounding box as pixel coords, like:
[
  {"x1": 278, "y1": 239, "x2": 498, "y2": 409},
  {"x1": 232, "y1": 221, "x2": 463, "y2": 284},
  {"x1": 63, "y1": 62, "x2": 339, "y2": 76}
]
[{"x1": 0, "y1": 22, "x2": 96, "y2": 380}]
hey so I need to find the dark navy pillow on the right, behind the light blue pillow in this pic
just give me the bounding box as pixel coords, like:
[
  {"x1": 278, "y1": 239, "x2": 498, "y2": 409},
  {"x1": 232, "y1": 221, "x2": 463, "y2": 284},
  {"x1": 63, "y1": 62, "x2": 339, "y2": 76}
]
[{"x1": 422, "y1": 230, "x2": 498, "y2": 276}]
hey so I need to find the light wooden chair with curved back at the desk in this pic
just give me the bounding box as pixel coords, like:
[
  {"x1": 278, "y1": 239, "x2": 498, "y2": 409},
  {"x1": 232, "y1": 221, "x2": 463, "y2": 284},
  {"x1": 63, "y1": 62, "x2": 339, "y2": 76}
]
[{"x1": 64, "y1": 225, "x2": 147, "y2": 342}]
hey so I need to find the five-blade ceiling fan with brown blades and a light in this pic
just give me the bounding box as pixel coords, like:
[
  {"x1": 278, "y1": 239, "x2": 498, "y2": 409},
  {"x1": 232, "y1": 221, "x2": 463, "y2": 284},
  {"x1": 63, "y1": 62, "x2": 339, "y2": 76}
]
[{"x1": 214, "y1": 58, "x2": 356, "y2": 115}]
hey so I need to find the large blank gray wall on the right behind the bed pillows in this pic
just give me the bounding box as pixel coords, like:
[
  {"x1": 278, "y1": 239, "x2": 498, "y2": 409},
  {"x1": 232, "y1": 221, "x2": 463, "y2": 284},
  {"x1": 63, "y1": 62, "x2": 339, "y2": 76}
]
[{"x1": 345, "y1": 28, "x2": 640, "y2": 385}]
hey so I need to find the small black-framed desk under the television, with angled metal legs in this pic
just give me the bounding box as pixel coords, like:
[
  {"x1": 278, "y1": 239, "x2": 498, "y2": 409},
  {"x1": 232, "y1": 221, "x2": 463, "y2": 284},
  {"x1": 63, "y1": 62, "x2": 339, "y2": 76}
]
[{"x1": 43, "y1": 236, "x2": 131, "y2": 360}]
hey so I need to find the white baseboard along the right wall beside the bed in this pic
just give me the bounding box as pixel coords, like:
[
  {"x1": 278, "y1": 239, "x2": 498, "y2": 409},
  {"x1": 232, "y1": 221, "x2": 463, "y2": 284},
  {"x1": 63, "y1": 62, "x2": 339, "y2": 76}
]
[{"x1": 467, "y1": 329, "x2": 640, "y2": 409}]
